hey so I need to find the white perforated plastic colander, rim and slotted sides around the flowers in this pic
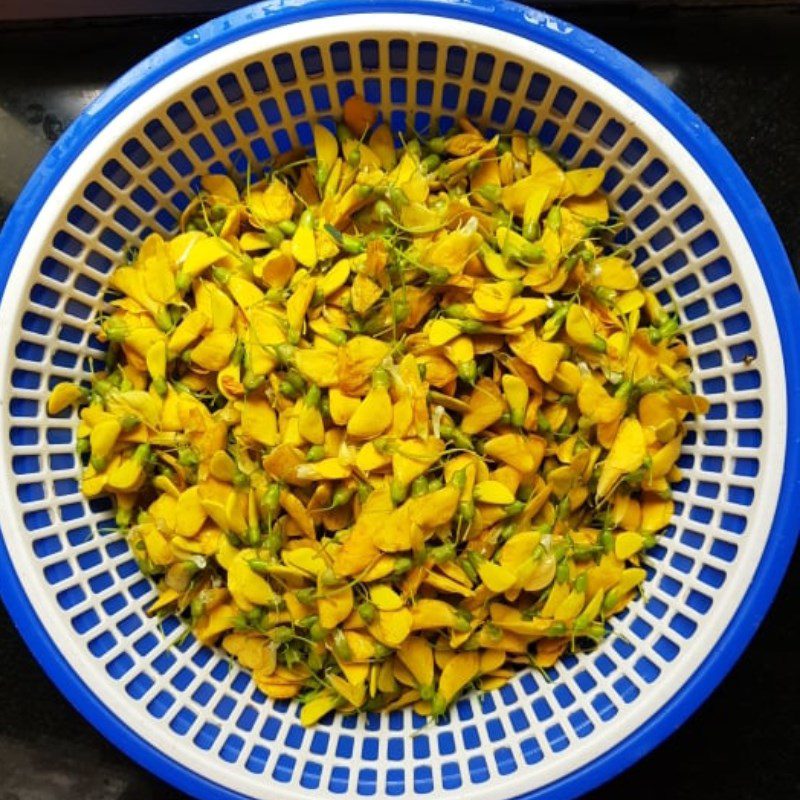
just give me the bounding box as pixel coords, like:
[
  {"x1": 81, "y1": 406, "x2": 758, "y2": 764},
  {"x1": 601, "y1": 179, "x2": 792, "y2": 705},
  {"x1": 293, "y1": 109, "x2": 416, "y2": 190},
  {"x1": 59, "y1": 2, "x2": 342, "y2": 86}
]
[{"x1": 0, "y1": 6, "x2": 788, "y2": 800}]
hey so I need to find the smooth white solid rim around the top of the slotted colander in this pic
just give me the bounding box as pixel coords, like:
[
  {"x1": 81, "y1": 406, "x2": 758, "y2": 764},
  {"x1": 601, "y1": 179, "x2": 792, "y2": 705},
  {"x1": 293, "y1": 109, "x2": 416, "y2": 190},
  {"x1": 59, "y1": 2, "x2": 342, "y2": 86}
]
[{"x1": 0, "y1": 14, "x2": 786, "y2": 800}]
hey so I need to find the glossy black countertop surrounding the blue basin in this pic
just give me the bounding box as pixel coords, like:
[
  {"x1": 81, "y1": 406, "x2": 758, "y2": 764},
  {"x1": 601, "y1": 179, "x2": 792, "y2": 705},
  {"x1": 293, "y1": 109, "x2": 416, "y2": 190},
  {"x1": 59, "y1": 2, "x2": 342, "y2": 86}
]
[{"x1": 0, "y1": 6, "x2": 800, "y2": 800}]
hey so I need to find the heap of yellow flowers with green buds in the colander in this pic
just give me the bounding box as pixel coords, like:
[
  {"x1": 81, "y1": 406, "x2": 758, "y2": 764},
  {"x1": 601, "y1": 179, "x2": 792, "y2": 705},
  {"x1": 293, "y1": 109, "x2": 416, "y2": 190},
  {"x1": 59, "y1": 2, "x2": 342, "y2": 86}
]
[{"x1": 49, "y1": 97, "x2": 707, "y2": 724}]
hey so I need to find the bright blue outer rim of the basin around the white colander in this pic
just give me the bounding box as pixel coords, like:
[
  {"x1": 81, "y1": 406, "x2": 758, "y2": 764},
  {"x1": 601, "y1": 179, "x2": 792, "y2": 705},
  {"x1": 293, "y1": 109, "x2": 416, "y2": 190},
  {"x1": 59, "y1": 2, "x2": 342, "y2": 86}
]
[{"x1": 0, "y1": 0, "x2": 800, "y2": 800}]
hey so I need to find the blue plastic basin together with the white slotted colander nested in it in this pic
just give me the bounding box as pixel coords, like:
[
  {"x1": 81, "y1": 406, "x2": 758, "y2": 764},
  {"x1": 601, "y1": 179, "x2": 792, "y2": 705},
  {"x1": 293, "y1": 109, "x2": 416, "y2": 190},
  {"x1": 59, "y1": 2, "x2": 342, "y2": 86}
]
[{"x1": 0, "y1": 0, "x2": 800, "y2": 800}]
